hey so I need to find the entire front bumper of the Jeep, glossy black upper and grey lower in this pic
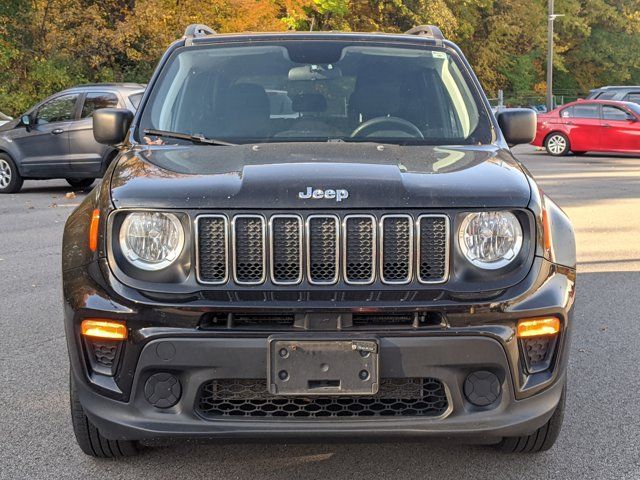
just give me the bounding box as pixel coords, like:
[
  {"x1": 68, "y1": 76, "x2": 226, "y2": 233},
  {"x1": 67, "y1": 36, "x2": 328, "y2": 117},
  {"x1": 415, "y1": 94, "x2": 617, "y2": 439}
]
[{"x1": 65, "y1": 259, "x2": 575, "y2": 441}]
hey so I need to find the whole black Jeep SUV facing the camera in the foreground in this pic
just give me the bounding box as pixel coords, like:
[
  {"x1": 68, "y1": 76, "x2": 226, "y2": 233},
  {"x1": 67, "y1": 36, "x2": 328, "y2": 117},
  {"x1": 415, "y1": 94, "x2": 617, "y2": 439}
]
[{"x1": 63, "y1": 26, "x2": 576, "y2": 457}]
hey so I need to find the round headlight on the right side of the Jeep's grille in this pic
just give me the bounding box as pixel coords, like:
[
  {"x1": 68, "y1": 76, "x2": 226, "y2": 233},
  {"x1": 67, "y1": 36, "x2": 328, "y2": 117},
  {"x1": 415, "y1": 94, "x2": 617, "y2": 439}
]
[{"x1": 458, "y1": 212, "x2": 522, "y2": 270}]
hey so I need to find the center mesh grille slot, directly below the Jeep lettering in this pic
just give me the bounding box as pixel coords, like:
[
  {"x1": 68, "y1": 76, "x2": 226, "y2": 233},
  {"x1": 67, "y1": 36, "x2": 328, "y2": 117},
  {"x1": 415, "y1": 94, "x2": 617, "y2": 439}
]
[{"x1": 307, "y1": 216, "x2": 338, "y2": 284}]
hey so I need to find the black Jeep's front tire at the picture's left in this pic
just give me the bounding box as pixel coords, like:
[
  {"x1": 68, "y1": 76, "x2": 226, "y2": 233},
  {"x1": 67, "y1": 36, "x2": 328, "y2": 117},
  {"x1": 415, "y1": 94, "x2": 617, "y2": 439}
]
[{"x1": 69, "y1": 373, "x2": 140, "y2": 458}]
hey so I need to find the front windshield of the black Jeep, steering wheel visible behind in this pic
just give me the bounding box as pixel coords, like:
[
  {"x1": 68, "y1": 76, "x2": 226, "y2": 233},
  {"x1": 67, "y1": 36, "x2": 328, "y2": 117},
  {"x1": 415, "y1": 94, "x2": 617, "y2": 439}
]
[{"x1": 138, "y1": 41, "x2": 492, "y2": 145}]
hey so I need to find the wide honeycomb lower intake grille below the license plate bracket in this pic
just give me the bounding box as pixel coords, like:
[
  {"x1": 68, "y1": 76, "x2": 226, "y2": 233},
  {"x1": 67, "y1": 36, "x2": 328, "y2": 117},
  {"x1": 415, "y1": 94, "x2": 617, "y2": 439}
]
[{"x1": 197, "y1": 378, "x2": 449, "y2": 418}]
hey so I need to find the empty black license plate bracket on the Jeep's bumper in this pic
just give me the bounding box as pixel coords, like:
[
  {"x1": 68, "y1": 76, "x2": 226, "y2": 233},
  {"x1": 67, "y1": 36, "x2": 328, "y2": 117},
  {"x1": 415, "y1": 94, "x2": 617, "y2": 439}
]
[{"x1": 267, "y1": 336, "x2": 380, "y2": 396}]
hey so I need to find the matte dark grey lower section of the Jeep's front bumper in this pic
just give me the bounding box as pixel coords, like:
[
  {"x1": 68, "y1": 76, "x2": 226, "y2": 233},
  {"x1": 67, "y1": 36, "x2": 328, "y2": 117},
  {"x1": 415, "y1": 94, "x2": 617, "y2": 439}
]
[{"x1": 75, "y1": 336, "x2": 565, "y2": 441}]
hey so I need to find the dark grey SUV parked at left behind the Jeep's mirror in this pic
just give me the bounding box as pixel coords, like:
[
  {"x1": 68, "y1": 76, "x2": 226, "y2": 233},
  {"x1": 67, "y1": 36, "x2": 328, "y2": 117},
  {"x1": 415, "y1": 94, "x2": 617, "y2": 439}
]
[{"x1": 0, "y1": 84, "x2": 144, "y2": 193}]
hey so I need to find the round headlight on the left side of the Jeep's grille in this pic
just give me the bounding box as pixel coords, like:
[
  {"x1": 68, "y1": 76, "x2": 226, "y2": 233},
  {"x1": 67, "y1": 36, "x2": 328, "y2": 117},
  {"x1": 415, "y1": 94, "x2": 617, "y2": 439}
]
[{"x1": 120, "y1": 212, "x2": 184, "y2": 270}]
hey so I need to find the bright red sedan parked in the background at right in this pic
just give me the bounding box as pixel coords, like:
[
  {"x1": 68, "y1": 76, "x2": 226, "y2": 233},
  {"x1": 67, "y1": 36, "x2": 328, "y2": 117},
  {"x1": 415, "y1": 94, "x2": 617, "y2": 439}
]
[{"x1": 531, "y1": 100, "x2": 640, "y2": 156}]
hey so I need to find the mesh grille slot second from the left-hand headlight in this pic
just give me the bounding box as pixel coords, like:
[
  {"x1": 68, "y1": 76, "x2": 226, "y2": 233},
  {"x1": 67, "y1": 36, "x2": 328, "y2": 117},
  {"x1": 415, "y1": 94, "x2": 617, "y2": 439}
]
[{"x1": 234, "y1": 216, "x2": 264, "y2": 283}]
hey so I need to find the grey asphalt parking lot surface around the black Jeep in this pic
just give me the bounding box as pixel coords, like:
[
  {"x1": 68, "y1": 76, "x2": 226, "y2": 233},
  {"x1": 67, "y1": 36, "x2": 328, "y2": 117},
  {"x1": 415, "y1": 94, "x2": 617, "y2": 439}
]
[{"x1": 0, "y1": 147, "x2": 640, "y2": 480}]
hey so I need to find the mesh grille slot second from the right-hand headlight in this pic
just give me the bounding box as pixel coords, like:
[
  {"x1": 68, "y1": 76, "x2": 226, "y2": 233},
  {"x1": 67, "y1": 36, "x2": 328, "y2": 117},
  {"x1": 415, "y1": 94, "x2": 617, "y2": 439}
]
[{"x1": 382, "y1": 216, "x2": 413, "y2": 283}]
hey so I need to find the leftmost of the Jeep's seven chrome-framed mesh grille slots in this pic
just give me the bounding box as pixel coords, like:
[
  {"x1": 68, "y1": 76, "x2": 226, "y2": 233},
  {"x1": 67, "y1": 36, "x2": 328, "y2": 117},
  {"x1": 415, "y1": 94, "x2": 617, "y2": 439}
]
[{"x1": 198, "y1": 217, "x2": 228, "y2": 283}]
